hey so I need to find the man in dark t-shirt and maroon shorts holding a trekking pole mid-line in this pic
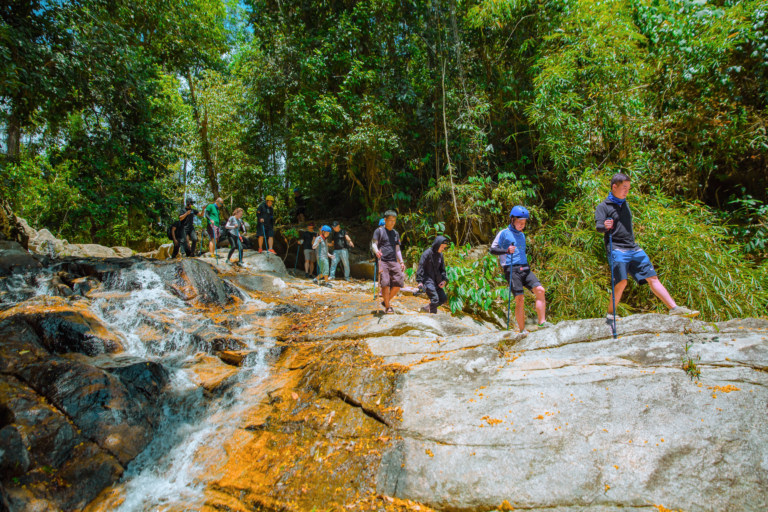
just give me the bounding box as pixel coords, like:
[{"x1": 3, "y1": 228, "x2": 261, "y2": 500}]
[{"x1": 371, "y1": 210, "x2": 405, "y2": 315}]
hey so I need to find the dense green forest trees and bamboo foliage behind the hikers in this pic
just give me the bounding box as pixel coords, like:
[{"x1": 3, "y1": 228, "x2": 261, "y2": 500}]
[{"x1": 0, "y1": 0, "x2": 768, "y2": 318}]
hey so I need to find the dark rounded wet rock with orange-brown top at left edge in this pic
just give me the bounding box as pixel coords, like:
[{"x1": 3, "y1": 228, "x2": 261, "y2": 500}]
[{"x1": 0, "y1": 296, "x2": 122, "y2": 356}]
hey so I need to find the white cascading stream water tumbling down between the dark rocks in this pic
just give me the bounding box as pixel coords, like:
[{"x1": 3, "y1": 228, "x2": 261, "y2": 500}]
[{"x1": 79, "y1": 268, "x2": 274, "y2": 512}]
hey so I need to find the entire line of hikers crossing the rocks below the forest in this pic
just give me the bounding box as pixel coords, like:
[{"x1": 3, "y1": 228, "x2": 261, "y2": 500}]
[{"x1": 169, "y1": 173, "x2": 699, "y2": 334}]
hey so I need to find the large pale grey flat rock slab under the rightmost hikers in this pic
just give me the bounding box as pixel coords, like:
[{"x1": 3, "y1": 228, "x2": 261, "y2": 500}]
[{"x1": 376, "y1": 315, "x2": 768, "y2": 511}]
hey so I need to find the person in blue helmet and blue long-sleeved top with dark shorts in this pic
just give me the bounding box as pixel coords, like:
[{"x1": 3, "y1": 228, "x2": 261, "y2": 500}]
[{"x1": 491, "y1": 206, "x2": 552, "y2": 335}]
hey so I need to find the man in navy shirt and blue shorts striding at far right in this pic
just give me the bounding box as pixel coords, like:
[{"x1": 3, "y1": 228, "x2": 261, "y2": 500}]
[{"x1": 595, "y1": 173, "x2": 699, "y2": 323}]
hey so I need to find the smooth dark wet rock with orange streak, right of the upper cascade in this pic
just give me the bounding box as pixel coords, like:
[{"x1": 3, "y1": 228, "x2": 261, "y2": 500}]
[{"x1": 154, "y1": 258, "x2": 231, "y2": 306}]
